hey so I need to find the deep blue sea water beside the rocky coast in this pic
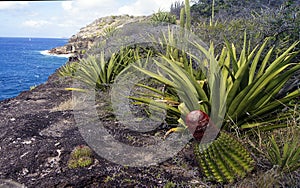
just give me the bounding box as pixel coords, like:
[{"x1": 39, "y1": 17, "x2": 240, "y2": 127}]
[{"x1": 0, "y1": 37, "x2": 68, "y2": 101}]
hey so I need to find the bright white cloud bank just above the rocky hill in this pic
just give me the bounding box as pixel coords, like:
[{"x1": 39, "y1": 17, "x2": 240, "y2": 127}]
[{"x1": 55, "y1": 0, "x2": 177, "y2": 37}]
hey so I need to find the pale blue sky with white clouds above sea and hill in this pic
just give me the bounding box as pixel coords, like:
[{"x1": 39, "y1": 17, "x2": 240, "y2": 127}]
[{"x1": 0, "y1": 0, "x2": 178, "y2": 38}]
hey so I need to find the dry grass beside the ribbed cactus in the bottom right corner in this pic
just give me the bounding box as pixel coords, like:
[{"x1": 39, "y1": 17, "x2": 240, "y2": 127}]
[{"x1": 232, "y1": 105, "x2": 300, "y2": 188}]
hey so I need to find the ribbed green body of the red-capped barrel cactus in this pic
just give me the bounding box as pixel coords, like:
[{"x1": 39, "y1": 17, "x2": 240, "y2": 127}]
[{"x1": 194, "y1": 131, "x2": 254, "y2": 182}]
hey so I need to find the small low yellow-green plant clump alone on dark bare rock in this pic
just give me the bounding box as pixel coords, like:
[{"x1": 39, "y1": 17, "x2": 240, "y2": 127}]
[{"x1": 68, "y1": 145, "x2": 93, "y2": 168}]
